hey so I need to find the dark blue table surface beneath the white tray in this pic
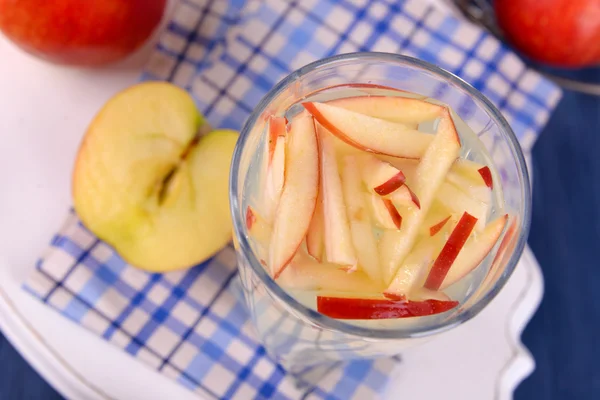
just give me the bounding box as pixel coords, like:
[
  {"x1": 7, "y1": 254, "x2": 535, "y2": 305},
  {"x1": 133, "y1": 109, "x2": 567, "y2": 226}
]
[{"x1": 0, "y1": 74, "x2": 600, "y2": 400}]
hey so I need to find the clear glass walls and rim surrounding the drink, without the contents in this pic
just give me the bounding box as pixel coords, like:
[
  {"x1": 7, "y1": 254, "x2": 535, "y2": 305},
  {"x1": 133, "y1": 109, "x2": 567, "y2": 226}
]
[{"x1": 230, "y1": 53, "x2": 531, "y2": 372}]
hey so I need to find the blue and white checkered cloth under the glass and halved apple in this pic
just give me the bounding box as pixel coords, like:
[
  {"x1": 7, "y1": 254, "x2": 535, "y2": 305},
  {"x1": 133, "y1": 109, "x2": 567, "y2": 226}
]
[{"x1": 25, "y1": 0, "x2": 560, "y2": 399}]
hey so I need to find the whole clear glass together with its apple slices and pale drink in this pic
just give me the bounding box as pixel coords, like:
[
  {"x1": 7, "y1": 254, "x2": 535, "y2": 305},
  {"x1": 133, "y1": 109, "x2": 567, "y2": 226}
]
[{"x1": 229, "y1": 53, "x2": 531, "y2": 373}]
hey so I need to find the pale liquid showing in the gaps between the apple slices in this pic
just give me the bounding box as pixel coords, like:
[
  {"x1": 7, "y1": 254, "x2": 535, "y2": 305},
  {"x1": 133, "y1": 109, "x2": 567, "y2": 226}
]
[{"x1": 243, "y1": 86, "x2": 505, "y2": 328}]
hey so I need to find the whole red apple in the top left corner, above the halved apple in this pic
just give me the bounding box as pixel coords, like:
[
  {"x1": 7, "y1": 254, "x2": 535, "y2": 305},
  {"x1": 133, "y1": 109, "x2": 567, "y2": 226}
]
[{"x1": 0, "y1": 0, "x2": 166, "y2": 66}]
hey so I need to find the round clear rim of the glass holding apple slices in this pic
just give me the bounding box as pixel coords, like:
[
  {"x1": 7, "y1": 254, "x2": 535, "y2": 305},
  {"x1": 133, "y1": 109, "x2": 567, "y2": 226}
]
[{"x1": 229, "y1": 52, "x2": 531, "y2": 339}]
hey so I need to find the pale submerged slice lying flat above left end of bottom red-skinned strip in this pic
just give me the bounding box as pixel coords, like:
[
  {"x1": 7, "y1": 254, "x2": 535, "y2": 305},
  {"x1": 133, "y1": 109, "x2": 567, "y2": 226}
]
[{"x1": 277, "y1": 251, "x2": 382, "y2": 293}]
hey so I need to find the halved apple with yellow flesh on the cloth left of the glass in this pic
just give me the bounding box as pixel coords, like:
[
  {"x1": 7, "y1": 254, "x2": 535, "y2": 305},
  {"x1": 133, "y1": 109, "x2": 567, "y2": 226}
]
[{"x1": 73, "y1": 82, "x2": 238, "y2": 271}]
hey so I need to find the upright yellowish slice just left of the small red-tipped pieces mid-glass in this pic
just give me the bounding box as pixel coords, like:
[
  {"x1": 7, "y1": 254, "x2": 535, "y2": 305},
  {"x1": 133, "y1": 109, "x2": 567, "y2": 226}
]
[{"x1": 342, "y1": 156, "x2": 383, "y2": 283}]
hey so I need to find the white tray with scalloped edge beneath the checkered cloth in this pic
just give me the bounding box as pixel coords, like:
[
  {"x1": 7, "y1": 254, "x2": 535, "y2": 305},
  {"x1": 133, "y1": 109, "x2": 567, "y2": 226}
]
[{"x1": 0, "y1": 1, "x2": 543, "y2": 400}]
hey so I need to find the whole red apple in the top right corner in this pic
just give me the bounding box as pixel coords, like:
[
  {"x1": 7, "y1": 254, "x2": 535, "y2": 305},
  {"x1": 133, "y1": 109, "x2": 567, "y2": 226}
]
[{"x1": 494, "y1": 0, "x2": 600, "y2": 67}]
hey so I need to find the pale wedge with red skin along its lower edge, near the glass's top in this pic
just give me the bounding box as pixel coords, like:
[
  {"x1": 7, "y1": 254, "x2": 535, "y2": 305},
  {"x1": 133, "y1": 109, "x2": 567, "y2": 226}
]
[{"x1": 302, "y1": 102, "x2": 433, "y2": 158}]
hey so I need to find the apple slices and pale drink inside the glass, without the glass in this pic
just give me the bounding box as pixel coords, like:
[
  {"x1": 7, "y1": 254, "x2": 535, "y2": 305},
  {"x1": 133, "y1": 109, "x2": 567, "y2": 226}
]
[{"x1": 241, "y1": 85, "x2": 510, "y2": 325}]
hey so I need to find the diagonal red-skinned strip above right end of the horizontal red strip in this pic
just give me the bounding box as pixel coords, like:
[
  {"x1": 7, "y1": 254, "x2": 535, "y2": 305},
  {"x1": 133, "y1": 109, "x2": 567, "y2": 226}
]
[{"x1": 425, "y1": 212, "x2": 477, "y2": 290}]
